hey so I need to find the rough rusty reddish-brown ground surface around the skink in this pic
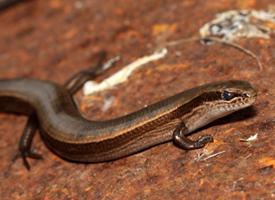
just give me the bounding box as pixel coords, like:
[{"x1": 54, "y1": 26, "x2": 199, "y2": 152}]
[{"x1": 0, "y1": 0, "x2": 275, "y2": 200}]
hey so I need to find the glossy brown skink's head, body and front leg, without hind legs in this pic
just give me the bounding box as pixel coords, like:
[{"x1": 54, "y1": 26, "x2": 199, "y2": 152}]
[{"x1": 0, "y1": 74, "x2": 256, "y2": 166}]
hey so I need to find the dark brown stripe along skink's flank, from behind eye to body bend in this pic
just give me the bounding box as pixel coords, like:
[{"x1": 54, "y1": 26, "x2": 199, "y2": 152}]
[{"x1": 44, "y1": 92, "x2": 224, "y2": 154}]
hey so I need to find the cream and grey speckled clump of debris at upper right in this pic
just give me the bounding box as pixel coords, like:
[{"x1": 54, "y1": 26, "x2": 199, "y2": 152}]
[{"x1": 200, "y1": 8, "x2": 275, "y2": 41}]
